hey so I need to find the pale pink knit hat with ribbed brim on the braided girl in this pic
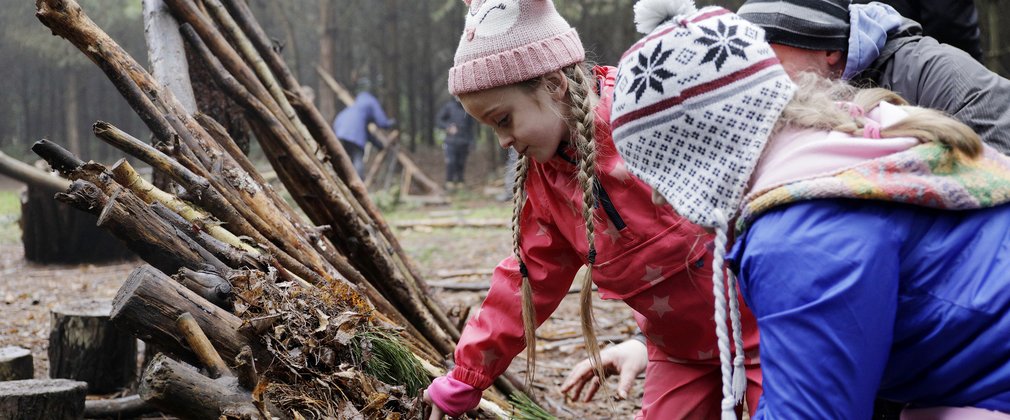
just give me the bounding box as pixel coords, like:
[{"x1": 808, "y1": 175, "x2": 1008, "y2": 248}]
[{"x1": 448, "y1": 0, "x2": 586, "y2": 95}]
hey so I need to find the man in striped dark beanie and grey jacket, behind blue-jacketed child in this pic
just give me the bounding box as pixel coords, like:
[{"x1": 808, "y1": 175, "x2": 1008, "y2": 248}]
[{"x1": 737, "y1": 0, "x2": 1010, "y2": 153}]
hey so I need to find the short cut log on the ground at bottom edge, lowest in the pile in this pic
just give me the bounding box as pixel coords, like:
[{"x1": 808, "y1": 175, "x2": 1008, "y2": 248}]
[{"x1": 139, "y1": 354, "x2": 263, "y2": 419}]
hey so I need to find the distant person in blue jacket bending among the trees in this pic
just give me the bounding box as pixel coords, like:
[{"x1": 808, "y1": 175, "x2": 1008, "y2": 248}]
[{"x1": 333, "y1": 78, "x2": 395, "y2": 177}]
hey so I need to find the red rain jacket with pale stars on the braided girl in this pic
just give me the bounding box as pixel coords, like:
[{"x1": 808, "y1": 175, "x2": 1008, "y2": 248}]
[{"x1": 450, "y1": 67, "x2": 758, "y2": 390}]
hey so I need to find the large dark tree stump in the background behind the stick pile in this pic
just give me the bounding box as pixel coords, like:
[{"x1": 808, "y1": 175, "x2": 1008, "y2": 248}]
[{"x1": 20, "y1": 182, "x2": 134, "y2": 264}]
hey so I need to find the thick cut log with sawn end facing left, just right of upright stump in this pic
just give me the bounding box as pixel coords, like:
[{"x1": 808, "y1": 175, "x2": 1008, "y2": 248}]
[{"x1": 111, "y1": 266, "x2": 272, "y2": 365}]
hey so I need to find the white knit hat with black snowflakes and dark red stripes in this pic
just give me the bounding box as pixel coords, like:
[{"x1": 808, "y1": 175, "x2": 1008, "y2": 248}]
[{"x1": 611, "y1": 0, "x2": 796, "y2": 227}]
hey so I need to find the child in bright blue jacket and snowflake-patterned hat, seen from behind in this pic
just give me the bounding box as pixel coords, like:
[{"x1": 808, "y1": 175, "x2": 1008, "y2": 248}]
[{"x1": 611, "y1": 0, "x2": 1010, "y2": 419}]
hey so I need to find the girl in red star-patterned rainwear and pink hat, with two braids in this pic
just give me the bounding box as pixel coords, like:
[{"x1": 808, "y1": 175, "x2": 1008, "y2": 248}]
[{"x1": 425, "y1": 0, "x2": 761, "y2": 419}]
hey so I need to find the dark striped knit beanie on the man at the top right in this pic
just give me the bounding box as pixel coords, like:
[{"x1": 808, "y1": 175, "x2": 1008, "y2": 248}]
[{"x1": 736, "y1": 0, "x2": 849, "y2": 51}]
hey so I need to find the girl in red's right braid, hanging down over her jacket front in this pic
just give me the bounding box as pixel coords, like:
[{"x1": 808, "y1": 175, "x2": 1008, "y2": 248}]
[{"x1": 565, "y1": 65, "x2": 605, "y2": 385}]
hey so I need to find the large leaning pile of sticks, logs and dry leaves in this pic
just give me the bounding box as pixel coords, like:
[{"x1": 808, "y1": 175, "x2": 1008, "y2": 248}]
[{"x1": 33, "y1": 0, "x2": 529, "y2": 418}]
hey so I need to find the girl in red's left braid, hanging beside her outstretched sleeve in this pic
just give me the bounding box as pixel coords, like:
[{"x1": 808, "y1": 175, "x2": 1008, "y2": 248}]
[{"x1": 512, "y1": 155, "x2": 536, "y2": 389}]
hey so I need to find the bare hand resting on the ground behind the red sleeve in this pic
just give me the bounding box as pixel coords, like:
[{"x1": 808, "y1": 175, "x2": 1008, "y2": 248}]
[{"x1": 562, "y1": 339, "x2": 648, "y2": 401}]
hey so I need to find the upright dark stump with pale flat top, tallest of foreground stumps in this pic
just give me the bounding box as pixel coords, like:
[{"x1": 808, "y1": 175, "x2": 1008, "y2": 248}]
[{"x1": 48, "y1": 300, "x2": 136, "y2": 394}]
